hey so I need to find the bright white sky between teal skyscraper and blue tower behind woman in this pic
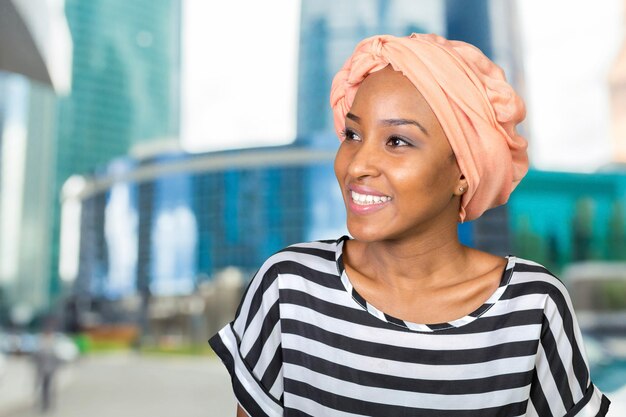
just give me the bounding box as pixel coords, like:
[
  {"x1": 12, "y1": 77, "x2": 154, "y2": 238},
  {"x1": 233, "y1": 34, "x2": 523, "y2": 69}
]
[{"x1": 181, "y1": 0, "x2": 300, "y2": 152}]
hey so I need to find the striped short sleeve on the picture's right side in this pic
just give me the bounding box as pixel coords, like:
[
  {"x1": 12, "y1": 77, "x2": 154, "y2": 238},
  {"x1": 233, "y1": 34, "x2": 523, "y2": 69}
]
[{"x1": 527, "y1": 278, "x2": 610, "y2": 417}]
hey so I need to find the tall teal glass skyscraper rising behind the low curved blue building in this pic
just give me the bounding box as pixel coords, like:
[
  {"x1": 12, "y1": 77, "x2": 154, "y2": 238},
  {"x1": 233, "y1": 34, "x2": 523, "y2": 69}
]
[{"x1": 49, "y1": 0, "x2": 180, "y2": 302}]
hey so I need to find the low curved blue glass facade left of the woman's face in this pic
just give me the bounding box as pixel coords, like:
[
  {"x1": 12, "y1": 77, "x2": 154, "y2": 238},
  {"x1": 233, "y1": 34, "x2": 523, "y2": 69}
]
[{"x1": 75, "y1": 147, "x2": 345, "y2": 299}]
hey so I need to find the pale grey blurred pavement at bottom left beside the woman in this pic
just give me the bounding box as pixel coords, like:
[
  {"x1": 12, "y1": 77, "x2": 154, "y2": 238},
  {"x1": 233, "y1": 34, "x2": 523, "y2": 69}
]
[{"x1": 0, "y1": 354, "x2": 236, "y2": 417}]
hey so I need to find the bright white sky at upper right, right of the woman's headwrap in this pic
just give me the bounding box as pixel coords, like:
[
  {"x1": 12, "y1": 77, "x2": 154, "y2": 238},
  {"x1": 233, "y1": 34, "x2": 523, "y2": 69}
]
[{"x1": 517, "y1": 0, "x2": 624, "y2": 172}]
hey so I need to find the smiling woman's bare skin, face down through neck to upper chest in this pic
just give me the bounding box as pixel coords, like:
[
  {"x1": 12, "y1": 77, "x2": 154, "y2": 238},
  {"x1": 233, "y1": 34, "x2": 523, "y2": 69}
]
[{"x1": 237, "y1": 66, "x2": 507, "y2": 417}]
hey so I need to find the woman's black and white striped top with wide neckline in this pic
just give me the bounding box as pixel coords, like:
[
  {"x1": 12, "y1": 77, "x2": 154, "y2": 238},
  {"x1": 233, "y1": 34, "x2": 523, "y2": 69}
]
[{"x1": 209, "y1": 236, "x2": 609, "y2": 417}]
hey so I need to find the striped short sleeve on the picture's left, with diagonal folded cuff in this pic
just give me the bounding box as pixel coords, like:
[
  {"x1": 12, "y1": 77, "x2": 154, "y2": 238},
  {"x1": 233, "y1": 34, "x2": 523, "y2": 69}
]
[{"x1": 209, "y1": 260, "x2": 283, "y2": 417}]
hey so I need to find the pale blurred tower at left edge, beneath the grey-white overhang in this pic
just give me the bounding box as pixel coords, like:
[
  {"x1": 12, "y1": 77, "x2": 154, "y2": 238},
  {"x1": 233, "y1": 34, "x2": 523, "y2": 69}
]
[{"x1": 0, "y1": 72, "x2": 57, "y2": 319}]
